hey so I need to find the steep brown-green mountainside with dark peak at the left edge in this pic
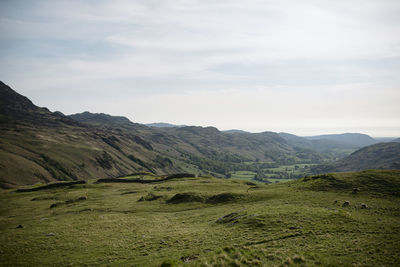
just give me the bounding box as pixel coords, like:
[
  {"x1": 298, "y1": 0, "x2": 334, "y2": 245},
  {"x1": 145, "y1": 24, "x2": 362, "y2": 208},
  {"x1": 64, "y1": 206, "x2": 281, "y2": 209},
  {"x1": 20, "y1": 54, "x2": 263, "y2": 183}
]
[{"x1": 0, "y1": 83, "x2": 181, "y2": 187}]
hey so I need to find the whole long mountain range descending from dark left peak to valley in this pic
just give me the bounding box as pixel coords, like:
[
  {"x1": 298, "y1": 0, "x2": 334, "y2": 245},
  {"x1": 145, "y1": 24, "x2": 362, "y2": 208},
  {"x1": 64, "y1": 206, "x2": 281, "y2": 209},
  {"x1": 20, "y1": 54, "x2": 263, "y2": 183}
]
[{"x1": 0, "y1": 83, "x2": 320, "y2": 187}]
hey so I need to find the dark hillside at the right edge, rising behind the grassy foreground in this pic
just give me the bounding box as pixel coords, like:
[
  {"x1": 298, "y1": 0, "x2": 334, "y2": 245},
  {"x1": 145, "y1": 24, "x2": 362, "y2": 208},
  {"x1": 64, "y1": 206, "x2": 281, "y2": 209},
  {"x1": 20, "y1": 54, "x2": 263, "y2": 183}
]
[{"x1": 313, "y1": 142, "x2": 400, "y2": 173}]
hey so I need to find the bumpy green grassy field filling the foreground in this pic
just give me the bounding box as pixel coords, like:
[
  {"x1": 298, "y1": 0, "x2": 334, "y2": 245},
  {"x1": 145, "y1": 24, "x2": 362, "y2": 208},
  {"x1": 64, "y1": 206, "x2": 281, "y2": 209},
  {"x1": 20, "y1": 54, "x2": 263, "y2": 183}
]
[{"x1": 0, "y1": 171, "x2": 400, "y2": 266}]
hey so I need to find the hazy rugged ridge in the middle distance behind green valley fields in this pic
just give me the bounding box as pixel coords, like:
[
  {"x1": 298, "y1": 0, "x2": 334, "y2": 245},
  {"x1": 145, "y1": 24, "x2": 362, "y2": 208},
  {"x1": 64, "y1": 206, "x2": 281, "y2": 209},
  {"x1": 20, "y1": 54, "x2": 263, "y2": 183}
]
[{"x1": 159, "y1": 126, "x2": 321, "y2": 169}]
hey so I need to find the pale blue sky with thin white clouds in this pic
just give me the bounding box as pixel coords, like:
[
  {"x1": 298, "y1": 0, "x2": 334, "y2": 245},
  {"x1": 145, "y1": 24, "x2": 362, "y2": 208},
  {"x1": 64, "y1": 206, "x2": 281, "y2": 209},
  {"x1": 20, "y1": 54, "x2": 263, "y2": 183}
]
[{"x1": 0, "y1": 0, "x2": 400, "y2": 137}]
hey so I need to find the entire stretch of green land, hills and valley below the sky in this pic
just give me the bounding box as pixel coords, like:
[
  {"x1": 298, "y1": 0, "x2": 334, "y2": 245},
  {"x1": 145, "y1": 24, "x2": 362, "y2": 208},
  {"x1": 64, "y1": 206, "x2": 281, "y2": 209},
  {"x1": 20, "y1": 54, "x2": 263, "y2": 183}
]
[{"x1": 0, "y1": 84, "x2": 400, "y2": 266}]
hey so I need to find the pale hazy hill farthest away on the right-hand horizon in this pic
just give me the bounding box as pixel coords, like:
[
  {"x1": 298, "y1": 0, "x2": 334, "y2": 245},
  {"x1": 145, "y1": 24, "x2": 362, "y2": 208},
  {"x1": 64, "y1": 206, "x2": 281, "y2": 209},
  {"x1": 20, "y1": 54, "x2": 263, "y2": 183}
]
[{"x1": 306, "y1": 133, "x2": 378, "y2": 148}]
